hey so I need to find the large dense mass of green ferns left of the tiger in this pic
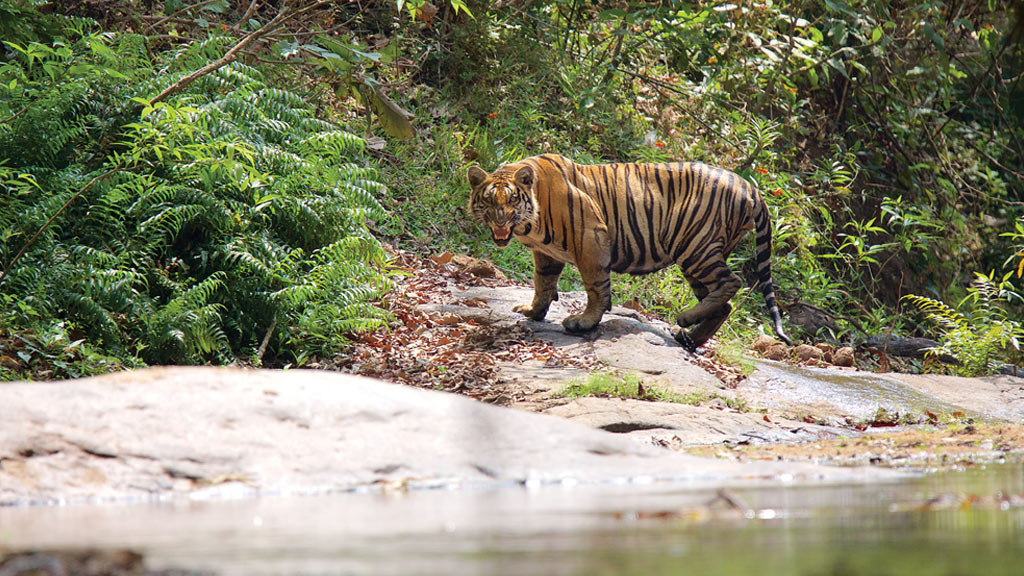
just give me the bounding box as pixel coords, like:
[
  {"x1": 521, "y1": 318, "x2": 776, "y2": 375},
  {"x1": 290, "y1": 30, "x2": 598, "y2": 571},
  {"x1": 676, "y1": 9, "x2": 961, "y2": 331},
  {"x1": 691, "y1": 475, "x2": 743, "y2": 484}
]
[{"x1": 0, "y1": 13, "x2": 388, "y2": 375}]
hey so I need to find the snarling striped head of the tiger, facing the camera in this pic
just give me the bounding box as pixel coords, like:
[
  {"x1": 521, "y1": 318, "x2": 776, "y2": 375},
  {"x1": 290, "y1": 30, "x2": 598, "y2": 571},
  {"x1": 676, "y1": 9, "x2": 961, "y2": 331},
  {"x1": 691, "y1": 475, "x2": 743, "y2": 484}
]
[{"x1": 466, "y1": 165, "x2": 538, "y2": 247}]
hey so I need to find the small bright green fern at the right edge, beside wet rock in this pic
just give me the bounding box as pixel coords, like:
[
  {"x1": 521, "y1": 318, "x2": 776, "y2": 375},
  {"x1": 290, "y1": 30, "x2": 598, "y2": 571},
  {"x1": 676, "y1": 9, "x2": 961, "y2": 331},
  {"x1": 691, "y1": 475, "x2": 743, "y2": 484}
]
[{"x1": 904, "y1": 274, "x2": 1024, "y2": 376}]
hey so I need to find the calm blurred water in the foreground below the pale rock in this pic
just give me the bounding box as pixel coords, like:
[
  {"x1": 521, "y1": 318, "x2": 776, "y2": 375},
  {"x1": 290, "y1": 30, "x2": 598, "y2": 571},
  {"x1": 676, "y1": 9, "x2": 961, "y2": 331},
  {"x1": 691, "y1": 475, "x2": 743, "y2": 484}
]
[{"x1": 0, "y1": 463, "x2": 1024, "y2": 576}]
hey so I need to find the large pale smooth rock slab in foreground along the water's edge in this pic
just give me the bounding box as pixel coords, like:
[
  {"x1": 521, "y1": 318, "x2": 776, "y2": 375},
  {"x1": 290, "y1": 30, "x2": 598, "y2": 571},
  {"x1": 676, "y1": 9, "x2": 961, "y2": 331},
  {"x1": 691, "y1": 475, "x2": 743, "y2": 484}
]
[{"x1": 0, "y1": 368, "x2": 891, "y2": 504}]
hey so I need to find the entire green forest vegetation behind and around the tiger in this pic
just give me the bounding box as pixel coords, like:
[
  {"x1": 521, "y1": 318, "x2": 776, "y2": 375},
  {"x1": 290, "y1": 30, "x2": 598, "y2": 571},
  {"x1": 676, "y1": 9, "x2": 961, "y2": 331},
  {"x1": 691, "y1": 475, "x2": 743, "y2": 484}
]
[{"x1": 0, "y1": 0, "x2": 1024, "y2": 379}]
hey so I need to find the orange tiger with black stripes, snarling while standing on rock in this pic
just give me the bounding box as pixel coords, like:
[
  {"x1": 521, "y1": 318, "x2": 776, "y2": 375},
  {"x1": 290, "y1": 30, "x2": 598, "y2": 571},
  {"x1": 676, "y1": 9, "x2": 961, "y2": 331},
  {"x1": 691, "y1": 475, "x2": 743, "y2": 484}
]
[{"x1": 466, "y1": 154, "x2": 792, "y2": 352}]
